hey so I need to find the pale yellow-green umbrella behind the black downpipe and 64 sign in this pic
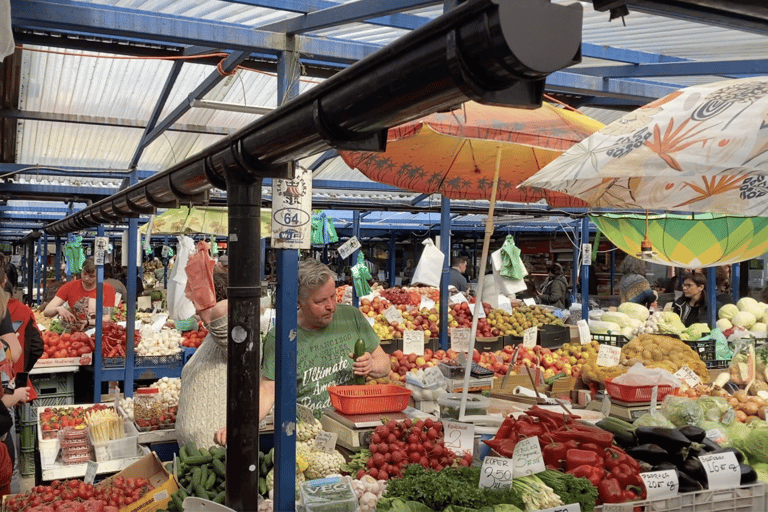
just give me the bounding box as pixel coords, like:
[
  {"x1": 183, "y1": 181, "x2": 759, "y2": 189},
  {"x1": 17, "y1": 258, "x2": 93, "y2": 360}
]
[{"x1": 139, "y1": 206, "x2": 272, "y2": 238}]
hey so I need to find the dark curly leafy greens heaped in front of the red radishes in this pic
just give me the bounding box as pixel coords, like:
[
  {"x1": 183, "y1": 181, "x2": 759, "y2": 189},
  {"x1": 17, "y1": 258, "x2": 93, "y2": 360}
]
[{"x1": 388, "y1": 464, "x2": 526, "y2": 512}]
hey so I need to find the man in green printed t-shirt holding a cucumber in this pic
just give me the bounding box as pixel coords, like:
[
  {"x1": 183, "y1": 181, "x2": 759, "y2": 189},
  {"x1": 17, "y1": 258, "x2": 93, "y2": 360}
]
[{"x1": 216, "y1": 259, "x2": 390, "y2": 444}]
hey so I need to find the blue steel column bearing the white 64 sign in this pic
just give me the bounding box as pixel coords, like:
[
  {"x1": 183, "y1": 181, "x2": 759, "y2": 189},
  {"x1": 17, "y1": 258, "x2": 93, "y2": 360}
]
[{"x1": 272, "y1": 35, "x2": 301, "y2": 512}]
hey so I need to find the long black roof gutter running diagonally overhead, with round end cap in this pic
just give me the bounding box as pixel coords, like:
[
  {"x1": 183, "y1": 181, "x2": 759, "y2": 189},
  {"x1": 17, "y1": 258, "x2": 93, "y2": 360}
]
[{"x1": 44, "y1": 0, "x2": 582, "y2": 235}]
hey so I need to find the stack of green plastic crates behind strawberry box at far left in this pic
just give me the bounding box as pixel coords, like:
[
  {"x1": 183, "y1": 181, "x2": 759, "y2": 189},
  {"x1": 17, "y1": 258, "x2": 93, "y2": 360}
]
[{"x1": 19, "y1": 372, "x2": 75, "y2": 476}]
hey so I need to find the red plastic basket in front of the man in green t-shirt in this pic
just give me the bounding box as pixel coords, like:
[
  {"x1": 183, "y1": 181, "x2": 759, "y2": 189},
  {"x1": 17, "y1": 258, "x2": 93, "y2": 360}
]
[{"x1": 328, "y1": 384, "x2": 411, "y2": 414}]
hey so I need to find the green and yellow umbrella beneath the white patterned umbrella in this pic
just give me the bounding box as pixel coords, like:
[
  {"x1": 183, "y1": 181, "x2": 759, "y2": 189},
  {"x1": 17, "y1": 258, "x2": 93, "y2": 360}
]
[{"x1": 590, "y1": 213, "x2": 768, "y2": 268}]
